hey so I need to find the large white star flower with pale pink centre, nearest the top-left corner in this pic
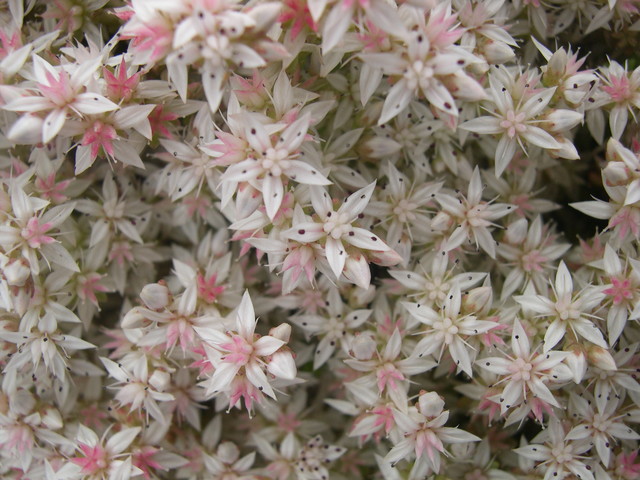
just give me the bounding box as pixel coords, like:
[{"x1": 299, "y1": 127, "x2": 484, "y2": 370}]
[{"x1": 2, "y1": 56, "x2": 118, "y2": 143}]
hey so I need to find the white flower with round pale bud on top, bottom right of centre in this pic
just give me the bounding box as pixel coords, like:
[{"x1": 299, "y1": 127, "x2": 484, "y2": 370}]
[{"x1": 384, "y1": 390, "x2": 480, "y2": 473}]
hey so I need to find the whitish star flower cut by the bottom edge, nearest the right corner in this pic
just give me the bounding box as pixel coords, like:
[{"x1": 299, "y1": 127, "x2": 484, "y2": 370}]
[{"x1": 514, "y1": 417, "x2": 595, "y2": 480}]
